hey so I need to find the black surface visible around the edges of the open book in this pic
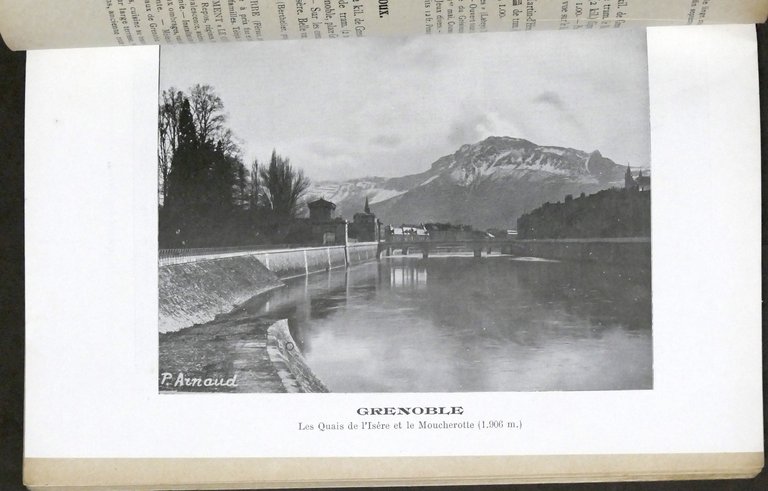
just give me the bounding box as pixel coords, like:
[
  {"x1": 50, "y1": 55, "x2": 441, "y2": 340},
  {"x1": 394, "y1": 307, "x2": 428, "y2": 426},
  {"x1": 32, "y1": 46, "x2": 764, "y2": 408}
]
[{"x1": 0, "y1": 24, "x2": 768, "y2": 491}]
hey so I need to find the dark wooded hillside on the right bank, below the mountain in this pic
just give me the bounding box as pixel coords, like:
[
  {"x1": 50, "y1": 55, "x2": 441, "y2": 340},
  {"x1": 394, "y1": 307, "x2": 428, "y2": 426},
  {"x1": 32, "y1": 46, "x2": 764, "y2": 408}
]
[{"x1": 517, "y1": 189, "x2": 651, "y2": 239}]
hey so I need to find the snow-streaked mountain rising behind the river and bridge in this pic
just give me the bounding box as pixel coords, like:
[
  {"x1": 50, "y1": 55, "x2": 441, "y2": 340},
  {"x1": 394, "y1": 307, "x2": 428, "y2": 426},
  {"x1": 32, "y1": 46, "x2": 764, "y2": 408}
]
[{"x1": 308, "y1": 136, "x2": 626, "y2": 229}]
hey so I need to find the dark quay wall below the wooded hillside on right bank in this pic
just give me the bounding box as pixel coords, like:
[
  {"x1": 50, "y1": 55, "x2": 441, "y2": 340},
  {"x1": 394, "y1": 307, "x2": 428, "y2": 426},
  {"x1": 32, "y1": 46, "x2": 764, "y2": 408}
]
[{"x1": 514, "y1": 237, "x2": 651, "y2": 267}]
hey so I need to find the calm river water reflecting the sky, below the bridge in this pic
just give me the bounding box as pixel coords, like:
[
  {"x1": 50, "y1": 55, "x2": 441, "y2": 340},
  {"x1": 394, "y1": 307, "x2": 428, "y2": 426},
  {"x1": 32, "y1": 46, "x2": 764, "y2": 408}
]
[{"x1": 236, "y1": 256, "x2": 653, "y2": 392}]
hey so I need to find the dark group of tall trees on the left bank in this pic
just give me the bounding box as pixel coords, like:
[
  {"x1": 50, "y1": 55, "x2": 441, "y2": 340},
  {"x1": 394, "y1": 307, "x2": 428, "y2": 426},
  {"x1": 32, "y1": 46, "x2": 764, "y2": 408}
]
[{"x1": 158, "y1": 85, "x2": 310, "y2": 248}]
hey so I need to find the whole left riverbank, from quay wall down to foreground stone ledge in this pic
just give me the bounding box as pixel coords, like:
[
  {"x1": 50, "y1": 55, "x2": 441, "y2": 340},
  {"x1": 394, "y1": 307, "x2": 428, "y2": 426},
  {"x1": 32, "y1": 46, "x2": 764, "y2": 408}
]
[{"x1": 158, "y1": 243, "x2": 378, "y2": 392}]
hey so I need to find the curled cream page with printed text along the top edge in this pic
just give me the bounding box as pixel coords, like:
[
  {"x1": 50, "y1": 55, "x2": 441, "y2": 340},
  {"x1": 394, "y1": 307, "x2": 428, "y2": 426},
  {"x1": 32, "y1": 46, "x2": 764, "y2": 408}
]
[{"x1": 0, "y1": 0, "x2": 768, "y2": 49}]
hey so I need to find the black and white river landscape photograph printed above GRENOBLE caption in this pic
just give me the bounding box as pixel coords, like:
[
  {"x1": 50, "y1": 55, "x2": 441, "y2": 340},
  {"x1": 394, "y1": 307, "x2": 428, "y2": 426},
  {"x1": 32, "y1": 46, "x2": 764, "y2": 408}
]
[{"x1": 157, "y1": 29, "x2": 661, "y2": 393}]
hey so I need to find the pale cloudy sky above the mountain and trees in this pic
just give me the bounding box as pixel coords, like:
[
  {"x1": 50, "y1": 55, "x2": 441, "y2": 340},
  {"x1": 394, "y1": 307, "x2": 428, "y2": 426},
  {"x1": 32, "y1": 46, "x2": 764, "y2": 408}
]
[{"x1": 160, "y1": 29, "x2": 650, "y2": 181}]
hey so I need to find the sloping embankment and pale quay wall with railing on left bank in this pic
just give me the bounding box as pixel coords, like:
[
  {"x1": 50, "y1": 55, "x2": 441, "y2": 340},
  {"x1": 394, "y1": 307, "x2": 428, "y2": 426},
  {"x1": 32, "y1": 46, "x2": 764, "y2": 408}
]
[{"x1": 158, "y1": 242, "x2": 378, "y2": 332}]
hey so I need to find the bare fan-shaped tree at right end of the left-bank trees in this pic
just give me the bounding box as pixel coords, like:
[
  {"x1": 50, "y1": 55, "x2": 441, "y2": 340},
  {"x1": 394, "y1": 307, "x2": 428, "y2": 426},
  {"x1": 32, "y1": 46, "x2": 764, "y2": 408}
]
[{"x1": 259, "y1": 150, "x2": 310, "y2": 218}]
